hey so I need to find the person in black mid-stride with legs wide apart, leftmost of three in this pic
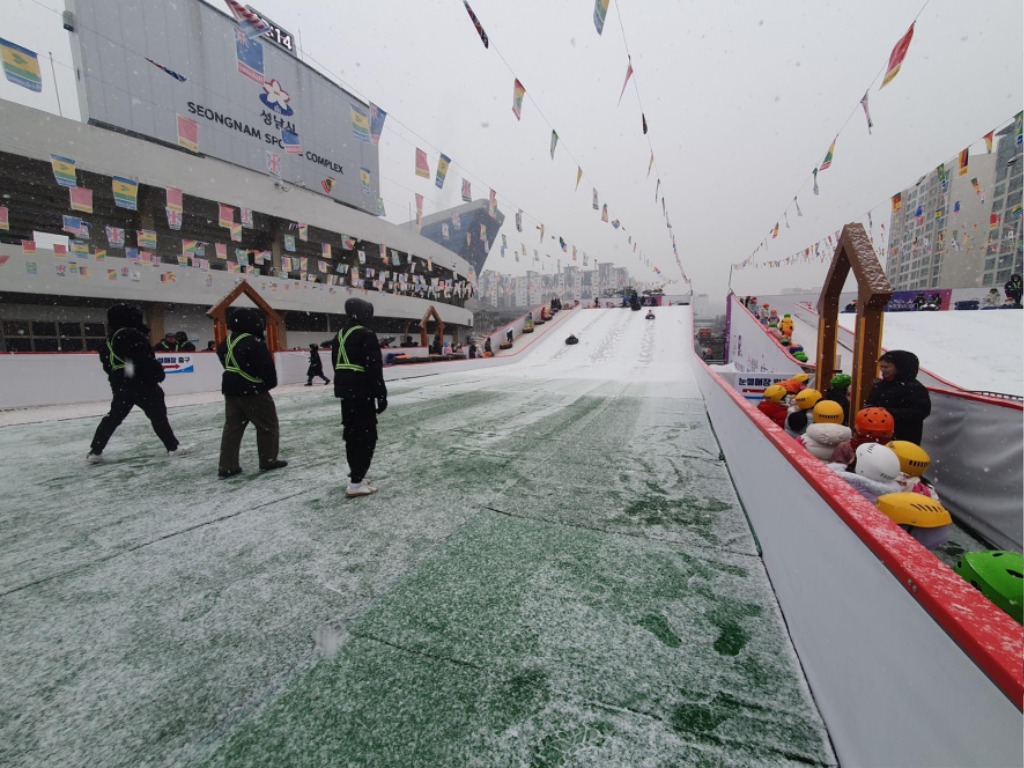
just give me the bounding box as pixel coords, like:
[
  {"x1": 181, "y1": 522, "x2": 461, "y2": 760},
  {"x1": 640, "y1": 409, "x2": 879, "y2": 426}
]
[{"x1": 86, "y1": 304, "x2": 194, "y2": 464}]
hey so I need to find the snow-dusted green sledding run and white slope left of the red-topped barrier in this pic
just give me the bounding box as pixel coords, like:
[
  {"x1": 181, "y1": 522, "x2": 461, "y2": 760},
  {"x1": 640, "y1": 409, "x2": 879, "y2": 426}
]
[{"x1": 0, "y1": 307, "x2": 835, "y2": 767}]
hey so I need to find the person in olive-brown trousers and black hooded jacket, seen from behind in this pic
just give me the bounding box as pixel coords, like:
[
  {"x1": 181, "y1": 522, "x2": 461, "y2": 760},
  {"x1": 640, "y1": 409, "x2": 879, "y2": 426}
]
[{"x1": 217, "y1": 307, "x2": 288, "y2": 477}]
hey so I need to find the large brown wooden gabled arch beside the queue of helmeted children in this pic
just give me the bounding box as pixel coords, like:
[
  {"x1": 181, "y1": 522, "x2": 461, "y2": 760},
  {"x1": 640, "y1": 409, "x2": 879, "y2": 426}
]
[{"x1": 815, "y1": 223, "x2": 893, "y2": 414}]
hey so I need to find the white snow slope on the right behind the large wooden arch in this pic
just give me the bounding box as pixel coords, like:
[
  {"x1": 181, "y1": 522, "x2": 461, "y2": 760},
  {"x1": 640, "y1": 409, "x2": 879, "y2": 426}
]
[{"x1": 794, "y1": 308, "x2": 1024, "y2": 396}]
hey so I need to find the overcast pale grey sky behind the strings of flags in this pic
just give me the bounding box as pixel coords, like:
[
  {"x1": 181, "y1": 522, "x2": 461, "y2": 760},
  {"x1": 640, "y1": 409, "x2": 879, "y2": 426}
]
[{"x1": 0, "y1": 0, "x2": 1024, "y2": 296}]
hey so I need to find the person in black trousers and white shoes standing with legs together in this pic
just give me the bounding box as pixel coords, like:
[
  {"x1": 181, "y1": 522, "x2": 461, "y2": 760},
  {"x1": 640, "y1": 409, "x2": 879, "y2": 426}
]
[{"x1": 331, "y1": 298, "x2": 387, "y2": 497}]
